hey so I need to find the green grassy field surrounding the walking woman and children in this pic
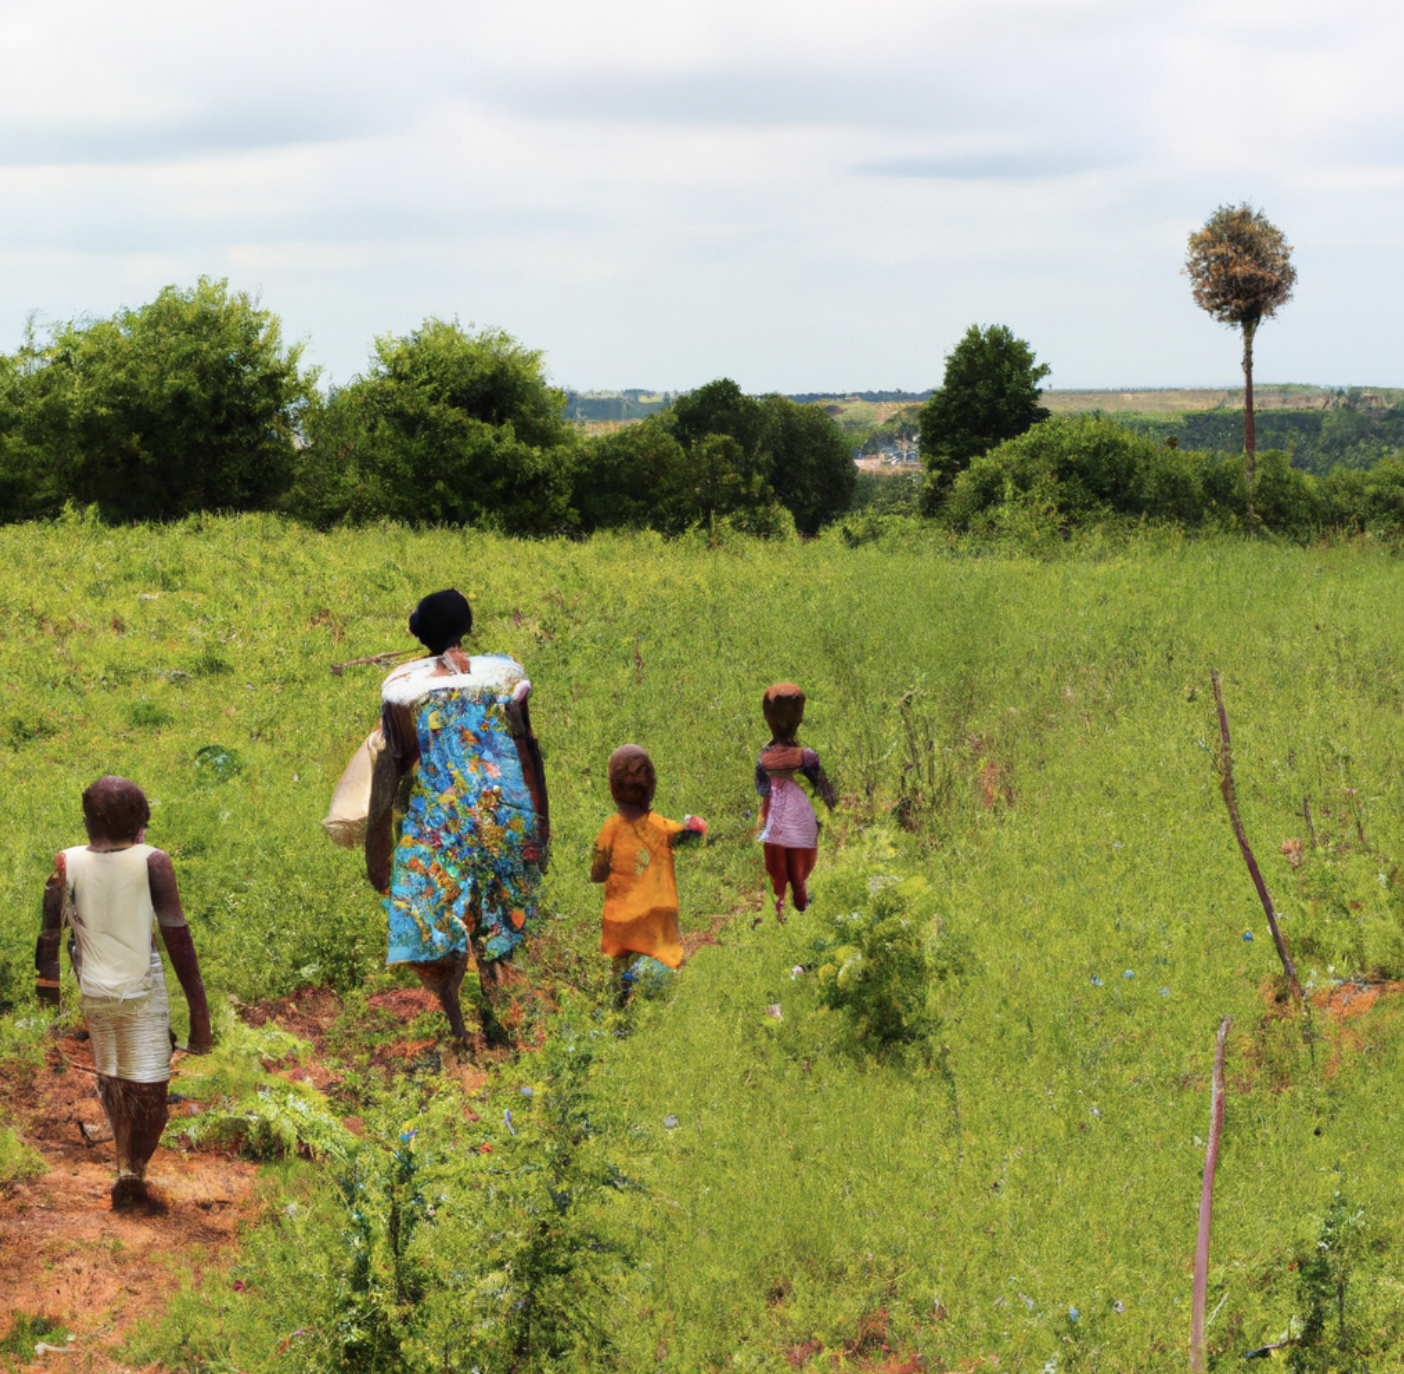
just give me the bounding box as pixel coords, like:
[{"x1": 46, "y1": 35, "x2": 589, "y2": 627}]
[{"x1": 0, "y1": 518, "x2": 1404, "y2": 1374}]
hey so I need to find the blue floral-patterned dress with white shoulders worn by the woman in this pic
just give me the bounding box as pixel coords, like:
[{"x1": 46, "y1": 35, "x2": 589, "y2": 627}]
[{"x1": 383, "y1": 654, "x2": 541, "y2": 964}]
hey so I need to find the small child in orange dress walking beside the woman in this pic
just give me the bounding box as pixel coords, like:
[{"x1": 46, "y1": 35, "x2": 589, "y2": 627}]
[{"x1": 590, "y1": 744, "x2": 706, "y2": 996}]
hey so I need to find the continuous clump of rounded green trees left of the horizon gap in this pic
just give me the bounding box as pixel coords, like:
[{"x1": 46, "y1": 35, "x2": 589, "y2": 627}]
[{"x1": 0, "y1": 278, "x2": 855, "y2": 535}]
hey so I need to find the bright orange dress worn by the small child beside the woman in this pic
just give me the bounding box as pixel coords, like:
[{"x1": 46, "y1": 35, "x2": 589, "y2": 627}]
[{"x1": 591, "y1": 811, "x2": 685, "y2": 968}]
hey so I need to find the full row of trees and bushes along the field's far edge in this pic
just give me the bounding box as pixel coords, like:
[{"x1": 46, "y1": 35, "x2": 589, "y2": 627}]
[{"x1": 8, "y1": 206, "x2": 1404, "y2": 538}]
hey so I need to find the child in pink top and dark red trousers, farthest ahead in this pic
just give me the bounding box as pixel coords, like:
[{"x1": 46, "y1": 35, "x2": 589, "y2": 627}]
[{"x1": 751, "y1": 682, "x2": 838, "y2": 929}]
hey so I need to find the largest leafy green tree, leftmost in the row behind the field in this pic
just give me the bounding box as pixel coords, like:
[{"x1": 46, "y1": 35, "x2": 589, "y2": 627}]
[{"x1": 0, "y1": 276, "x2": 316, "y2": 521}]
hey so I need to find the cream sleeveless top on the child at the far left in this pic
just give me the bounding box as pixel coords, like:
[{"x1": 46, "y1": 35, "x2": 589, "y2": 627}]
[{"x1": 63, "y1": 845, "x2": 156, "y2": 1002}]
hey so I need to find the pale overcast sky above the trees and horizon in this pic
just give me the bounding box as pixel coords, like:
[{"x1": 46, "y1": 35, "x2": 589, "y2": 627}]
[{"x1": 0, "y1": 0, "x2": 1404, "y2": 392}]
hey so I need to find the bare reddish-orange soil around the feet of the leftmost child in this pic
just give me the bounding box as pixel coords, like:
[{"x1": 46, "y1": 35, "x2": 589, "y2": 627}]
[{"x1": 0, "y1": 1034, "x2": 258, "y2": 1370}]
